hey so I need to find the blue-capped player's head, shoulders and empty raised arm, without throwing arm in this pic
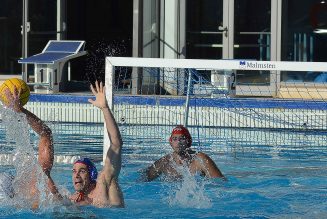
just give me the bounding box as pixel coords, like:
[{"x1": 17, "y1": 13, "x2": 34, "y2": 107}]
[{"x1": 69, "y1": 82, "x2": 124, "y2": 207}]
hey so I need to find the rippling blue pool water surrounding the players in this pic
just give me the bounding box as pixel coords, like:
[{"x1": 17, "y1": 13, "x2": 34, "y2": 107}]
[{"x1": 0, "y1": 119, "x2": 327, "y2": 218}]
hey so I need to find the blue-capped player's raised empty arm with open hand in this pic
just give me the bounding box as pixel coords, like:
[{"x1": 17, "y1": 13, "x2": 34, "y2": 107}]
[{"x1": 89, "y1": 81, "x2": 124, "y2": 206}]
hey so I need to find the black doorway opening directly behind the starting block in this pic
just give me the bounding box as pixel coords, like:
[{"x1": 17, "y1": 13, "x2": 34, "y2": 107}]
[{"x1": 67, "y1": 0, "x2": 133, "y2": 82}]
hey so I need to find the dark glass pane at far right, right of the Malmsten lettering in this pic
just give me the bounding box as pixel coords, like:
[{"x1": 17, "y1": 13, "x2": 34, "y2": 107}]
[{"x1": 281, "y1": 0, "x2": 327, "y2": 83}]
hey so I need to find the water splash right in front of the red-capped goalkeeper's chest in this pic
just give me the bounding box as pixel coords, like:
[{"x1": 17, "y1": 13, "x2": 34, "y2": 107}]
[{"x1": 167, "y1": 158, "x2": 212, "y2": 208}]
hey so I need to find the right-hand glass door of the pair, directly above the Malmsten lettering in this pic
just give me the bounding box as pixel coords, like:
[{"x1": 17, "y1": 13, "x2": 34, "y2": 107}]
[{"x1": 234, "y1": 0, "x2": 271, "y2": 85}]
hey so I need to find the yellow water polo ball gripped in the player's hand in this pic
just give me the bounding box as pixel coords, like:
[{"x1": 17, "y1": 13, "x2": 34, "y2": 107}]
[{"x1": 0, "y1": 78, "x2": 30, "y2": 106}]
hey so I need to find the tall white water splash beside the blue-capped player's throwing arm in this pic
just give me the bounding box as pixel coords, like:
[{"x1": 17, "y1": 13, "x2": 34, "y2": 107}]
[{"x1": 0, "y1": 106, "x2": 53, "y2": 208}]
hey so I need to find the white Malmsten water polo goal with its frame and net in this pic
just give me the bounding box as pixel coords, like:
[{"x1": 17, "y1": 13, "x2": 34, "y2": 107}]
[{"x1": 105, "y1": 57, "x2": 327, "y2": 161}]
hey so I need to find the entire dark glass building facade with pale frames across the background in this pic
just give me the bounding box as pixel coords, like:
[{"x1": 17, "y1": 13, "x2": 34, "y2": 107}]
[{"x1": 0, "y1": 0, "x2": 327, "y2": 95}]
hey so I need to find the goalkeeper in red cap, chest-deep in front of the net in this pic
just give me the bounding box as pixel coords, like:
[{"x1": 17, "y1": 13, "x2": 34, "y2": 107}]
[{"x1": 144, "y1": 125, "x2": 224, "y2": 181}]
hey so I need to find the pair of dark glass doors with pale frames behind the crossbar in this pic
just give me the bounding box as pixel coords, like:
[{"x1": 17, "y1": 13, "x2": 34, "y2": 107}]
[{"x1": 186, "y1": 0, "x2": 271, "y2": 85}]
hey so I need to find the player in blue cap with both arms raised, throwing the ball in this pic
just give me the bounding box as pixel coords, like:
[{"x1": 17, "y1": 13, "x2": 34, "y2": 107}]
[{"x1": 0, "y1": 82, "x2": 124, "y2": 208}]
